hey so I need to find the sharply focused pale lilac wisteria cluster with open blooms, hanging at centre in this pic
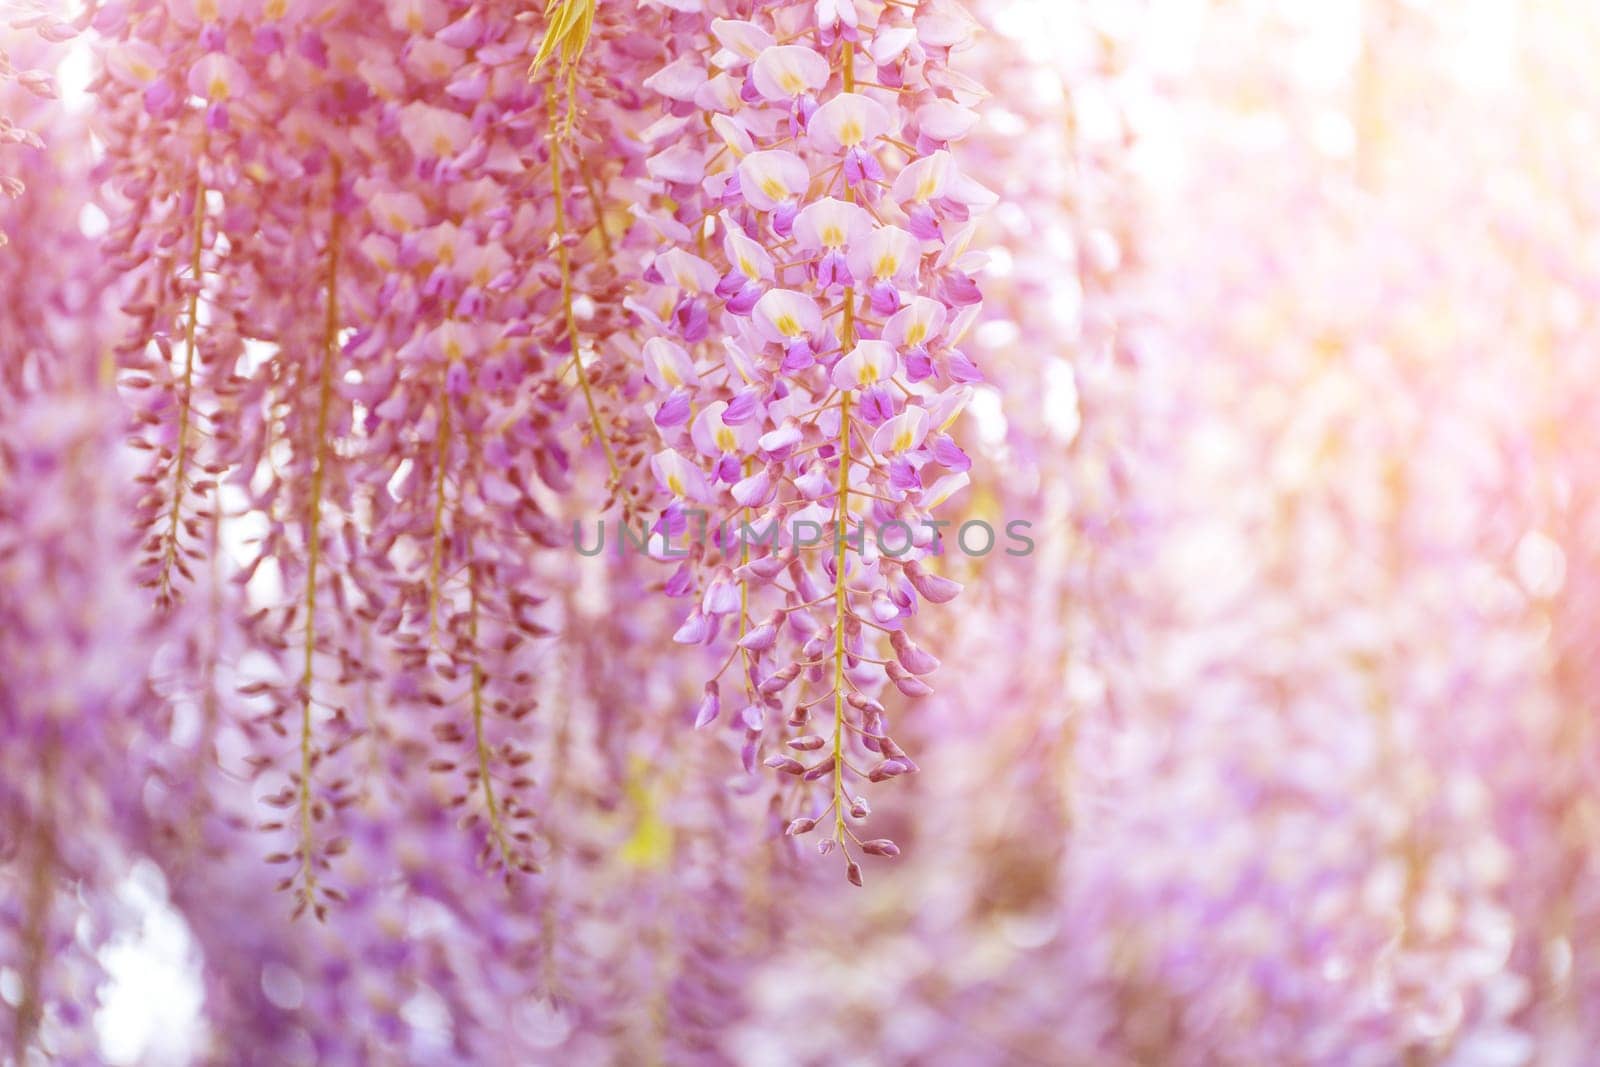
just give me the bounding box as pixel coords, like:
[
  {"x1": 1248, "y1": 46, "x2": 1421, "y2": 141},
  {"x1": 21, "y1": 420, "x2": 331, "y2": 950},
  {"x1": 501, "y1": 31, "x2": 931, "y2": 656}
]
[{"x1": 629, "y1": 3, "x2": 994, "y2": 883}]
